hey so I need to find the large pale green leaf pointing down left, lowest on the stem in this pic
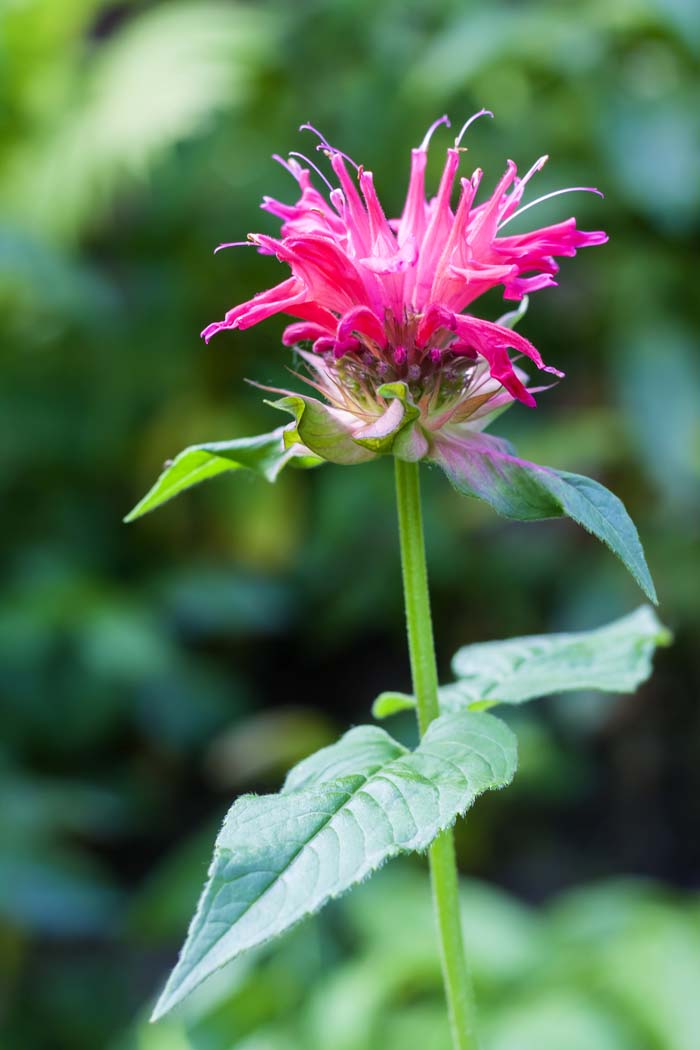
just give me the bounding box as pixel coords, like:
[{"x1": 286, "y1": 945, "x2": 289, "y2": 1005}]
[{"x1": 153, "y1": 712, "x2": 516, "y2": 1019}]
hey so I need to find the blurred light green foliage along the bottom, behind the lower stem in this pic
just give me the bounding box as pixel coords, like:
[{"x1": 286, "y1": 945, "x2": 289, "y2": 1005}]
[{"x1": 121, "y1": 861, "x2": 700, "y2": 1050}]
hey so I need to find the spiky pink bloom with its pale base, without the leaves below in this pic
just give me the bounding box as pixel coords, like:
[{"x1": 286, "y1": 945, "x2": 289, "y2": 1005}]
[{"x1": 203, "y1": 110, "x2": 607, "y2": 434}]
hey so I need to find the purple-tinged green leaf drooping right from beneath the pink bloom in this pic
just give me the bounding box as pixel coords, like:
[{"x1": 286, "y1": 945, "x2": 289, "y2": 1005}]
[{"x1": 430, "y1": 431, "x2": 657, "y2": 604}]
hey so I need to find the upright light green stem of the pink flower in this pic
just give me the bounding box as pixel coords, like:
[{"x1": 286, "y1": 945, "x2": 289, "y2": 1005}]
[{"x1": 395, "y1": 459, "x2": 479, "y2": 1050}]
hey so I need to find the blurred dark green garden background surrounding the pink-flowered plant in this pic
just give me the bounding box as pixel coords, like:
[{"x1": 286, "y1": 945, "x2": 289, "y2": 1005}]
[{"x1": 0, "y1": 0, "x2": 700, "y2": 1050}]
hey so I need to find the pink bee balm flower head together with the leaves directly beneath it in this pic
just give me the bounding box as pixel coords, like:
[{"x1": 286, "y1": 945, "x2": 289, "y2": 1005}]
[{"x1": 127, "y1": 116, "x2": 656, "y2": 601}]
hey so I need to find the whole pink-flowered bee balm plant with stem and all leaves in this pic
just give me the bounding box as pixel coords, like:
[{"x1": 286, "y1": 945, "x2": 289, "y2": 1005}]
[{"x1": 127, "y1": 110, "x2": 669, "y2": 1050}]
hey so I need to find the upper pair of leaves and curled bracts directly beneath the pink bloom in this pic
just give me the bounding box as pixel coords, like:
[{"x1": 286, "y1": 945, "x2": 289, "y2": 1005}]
[{"x1": 125, "y1": 401, "x2": 656, "y2": 603}]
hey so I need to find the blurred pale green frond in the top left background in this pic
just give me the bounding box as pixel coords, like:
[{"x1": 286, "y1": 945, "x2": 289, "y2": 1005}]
[{"x1": 0, "y1": 0, "x2": 274, "y2": 239}]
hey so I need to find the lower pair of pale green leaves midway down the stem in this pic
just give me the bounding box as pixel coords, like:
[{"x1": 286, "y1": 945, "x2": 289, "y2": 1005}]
[{"x1": 153, "y1": 606, "x2": 671, "y2": 1017}]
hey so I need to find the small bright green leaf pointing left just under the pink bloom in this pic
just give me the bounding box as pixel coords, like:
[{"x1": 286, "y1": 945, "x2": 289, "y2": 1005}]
[{"x1": 124, "y1": 426, "x2": 320, "y2": 522}]
